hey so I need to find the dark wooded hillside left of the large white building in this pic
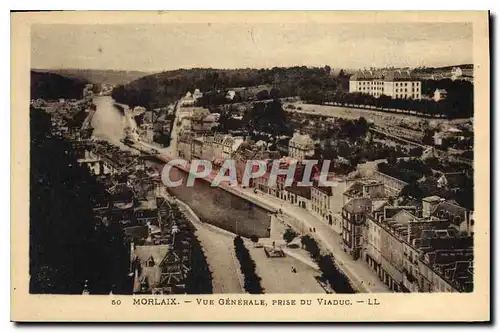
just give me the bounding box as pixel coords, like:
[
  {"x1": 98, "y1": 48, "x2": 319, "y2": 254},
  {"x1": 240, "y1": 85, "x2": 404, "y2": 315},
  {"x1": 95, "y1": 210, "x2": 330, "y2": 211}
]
[{"x1": 112, "y1": 66, "x2": 341, "y2": 107}]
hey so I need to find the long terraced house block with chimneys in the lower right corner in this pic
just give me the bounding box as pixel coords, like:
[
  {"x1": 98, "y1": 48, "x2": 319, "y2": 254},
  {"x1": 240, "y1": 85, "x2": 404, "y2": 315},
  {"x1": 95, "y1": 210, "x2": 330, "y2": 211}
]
[{"x1": 361, "y1": 197, "x2": 474, "y2": 292}]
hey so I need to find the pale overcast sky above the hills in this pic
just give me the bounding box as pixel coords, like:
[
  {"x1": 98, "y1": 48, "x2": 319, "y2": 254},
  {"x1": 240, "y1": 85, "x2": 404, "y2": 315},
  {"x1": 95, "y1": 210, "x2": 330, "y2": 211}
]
[{"x1": 31, "y1": 23, "x2": 473, "y2": 71}]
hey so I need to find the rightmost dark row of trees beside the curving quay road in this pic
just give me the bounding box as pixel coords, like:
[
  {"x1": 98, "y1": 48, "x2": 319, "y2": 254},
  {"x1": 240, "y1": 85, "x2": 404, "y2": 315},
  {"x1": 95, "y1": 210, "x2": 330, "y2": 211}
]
[{"x1": 300, "y1": 235, "x2": 356, "y2": 294}]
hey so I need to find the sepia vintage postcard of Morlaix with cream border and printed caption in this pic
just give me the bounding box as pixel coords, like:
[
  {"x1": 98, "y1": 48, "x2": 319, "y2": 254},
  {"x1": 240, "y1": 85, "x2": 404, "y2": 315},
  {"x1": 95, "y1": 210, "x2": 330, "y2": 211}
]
[{"x1": 11, "y1": 11, "x2": 490, "y2": 322}]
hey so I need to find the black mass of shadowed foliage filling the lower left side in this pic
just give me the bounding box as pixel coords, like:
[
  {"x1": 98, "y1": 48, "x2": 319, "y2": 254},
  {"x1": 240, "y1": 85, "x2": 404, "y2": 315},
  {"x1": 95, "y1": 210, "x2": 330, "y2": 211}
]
[{"x1": 29, "y1": 108, "x2": 131, "y2": 294}]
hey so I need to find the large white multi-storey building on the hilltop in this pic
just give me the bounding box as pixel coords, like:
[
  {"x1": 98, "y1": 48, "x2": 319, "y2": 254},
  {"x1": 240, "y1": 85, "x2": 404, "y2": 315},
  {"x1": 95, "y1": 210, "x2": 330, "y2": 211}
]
[{"x1": 349, "y1": 70, "x2": 422, "y2": 99}]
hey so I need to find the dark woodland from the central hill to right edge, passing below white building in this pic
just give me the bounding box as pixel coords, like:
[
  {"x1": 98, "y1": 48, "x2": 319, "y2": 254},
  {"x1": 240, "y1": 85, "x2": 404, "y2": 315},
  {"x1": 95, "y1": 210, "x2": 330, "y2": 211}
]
[{"x1": 112, "y1": 66, "x2": 474, "y2": 118}]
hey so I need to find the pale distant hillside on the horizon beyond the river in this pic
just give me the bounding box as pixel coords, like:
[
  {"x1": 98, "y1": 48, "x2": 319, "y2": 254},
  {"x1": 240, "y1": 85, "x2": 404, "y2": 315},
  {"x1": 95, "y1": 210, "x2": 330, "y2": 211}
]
[{"x1": 33, "y1": 69, "x2": 151, "y2": 85}]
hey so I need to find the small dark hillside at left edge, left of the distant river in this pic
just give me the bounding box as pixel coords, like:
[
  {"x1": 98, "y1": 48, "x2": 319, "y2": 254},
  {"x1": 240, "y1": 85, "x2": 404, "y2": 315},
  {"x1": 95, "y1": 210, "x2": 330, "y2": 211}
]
[{"x1": 30, "y1": 71, "x2": 87, "y2": 100}]
